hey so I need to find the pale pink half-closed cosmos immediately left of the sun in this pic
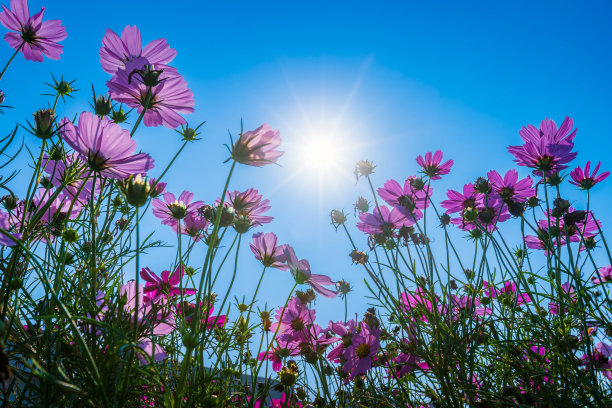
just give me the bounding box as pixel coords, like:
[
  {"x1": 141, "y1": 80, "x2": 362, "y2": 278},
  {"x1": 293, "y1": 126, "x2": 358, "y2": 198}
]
[{"x1": 232, "y1": 123, "x2": 284, "y2": 167}]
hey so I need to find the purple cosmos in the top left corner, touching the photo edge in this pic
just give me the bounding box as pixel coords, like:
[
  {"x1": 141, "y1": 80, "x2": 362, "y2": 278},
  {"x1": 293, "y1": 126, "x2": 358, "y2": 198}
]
[{"x1": 0, "y1": 0, "x2": 67, "y2": 62}]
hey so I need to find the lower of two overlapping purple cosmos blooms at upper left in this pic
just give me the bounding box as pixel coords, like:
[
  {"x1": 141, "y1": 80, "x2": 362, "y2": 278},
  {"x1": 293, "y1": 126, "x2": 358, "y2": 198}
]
[{"x1": 106, "y1": 62, "x2": 195, "y2": 129}]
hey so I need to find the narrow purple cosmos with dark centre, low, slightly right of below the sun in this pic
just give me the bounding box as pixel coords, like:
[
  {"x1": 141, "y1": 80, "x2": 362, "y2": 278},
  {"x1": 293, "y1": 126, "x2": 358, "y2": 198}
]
[{"x1": 343, "y1": 322, "x2": 380, "y2": 383}]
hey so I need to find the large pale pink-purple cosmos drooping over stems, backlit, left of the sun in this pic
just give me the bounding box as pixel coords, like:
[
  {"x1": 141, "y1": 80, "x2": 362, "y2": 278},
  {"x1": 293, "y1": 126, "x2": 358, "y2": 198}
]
[{"x1": 59, "y1": 112, "x2": 153, "y2": 180}]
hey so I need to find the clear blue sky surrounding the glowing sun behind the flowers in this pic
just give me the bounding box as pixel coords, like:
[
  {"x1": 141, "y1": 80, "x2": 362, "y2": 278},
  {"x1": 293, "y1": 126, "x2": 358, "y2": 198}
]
[{"x1": 0, "y1": 0, "x2": 612, "y2": 323}]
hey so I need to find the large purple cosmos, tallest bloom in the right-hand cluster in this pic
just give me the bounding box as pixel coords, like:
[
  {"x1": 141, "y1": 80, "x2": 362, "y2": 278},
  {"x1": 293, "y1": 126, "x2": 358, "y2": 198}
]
[{"x1": 508, "y1": 116, "x2": 578, "y2": 176}]
